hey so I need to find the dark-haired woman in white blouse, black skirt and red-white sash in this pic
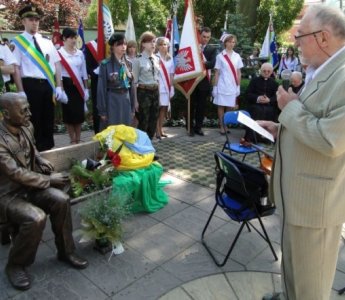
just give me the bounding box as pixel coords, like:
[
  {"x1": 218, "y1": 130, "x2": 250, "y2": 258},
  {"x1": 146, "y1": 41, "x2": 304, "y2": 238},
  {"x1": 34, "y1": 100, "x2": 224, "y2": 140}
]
[{"x1": 58, "y1": 28, "x2": 89, "y2": 144}]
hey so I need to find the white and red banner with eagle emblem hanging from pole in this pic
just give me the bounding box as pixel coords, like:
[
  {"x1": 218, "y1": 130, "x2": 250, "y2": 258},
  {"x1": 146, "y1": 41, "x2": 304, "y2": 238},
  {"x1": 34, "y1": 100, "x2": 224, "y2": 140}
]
[{"x1": 174, "y1": 0, "x2": 205, "y2": 99}]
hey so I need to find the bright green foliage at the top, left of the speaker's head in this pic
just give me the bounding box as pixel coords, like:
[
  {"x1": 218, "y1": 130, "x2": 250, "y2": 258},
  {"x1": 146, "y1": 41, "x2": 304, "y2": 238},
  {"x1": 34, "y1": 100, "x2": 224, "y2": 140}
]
[{"x1": 256, "y1": 0, "x2": 304, "y2": 39}]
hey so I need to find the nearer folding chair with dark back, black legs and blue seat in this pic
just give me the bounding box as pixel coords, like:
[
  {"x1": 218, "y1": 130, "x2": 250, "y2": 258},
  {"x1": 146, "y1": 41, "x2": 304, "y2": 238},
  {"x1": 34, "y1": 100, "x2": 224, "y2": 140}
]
[{"x1": 201, "y1": 152, "x2": 278, "y2": 267}]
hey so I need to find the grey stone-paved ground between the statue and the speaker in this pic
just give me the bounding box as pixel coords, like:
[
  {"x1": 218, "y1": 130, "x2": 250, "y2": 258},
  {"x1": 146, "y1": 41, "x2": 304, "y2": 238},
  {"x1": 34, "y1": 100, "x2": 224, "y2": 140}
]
[{"x1": 0, "y1": 128, "x2": 345, "y2": 300}]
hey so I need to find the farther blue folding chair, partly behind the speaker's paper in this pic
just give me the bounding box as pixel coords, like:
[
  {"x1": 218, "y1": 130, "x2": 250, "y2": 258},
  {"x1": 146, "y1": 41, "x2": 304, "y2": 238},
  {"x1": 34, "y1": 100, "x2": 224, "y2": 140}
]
[{"x1": 222, "y1": 110, "x2": 263, "y2": 164}]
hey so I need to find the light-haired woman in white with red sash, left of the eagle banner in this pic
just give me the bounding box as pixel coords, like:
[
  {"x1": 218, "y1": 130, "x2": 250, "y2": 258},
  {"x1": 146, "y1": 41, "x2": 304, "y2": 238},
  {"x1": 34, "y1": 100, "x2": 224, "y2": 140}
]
[{"x1": 156, "y1": 37, "x2": 174, "y2": 139}]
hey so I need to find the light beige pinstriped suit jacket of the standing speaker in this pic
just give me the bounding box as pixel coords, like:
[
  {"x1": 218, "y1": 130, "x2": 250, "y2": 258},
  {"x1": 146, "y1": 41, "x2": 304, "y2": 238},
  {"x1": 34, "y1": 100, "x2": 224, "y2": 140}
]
[{"x1": 272, "y1": 50, "x2": 345, "y2": 228}]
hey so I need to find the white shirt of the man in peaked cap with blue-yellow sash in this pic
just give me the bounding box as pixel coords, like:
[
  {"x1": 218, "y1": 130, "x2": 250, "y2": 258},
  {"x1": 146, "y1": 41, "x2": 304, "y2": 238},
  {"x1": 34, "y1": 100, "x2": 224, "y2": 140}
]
[{"x1": 13, "y1": 31, "x2": 60, "y2": 79}]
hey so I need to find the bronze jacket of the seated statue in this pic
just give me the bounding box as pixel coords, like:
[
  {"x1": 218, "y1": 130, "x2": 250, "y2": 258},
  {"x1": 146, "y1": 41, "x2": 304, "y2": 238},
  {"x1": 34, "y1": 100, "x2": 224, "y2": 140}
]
[{"x1": 0, "y1": 123, "x2": 50, "y2": 223}]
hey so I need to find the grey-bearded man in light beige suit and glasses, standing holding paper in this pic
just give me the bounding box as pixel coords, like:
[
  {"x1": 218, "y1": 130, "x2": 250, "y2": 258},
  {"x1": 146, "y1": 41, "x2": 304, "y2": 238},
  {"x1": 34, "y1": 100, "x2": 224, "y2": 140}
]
[{"x1": 259, "y1": 5, "x2": 345, "y2": 300}]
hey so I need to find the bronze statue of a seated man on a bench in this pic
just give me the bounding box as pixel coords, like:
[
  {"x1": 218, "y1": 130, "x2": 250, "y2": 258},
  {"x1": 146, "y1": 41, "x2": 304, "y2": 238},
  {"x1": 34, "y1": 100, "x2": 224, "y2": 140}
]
[{"x1": 0, "y1": 93, "x2": 88, "y2": 290}]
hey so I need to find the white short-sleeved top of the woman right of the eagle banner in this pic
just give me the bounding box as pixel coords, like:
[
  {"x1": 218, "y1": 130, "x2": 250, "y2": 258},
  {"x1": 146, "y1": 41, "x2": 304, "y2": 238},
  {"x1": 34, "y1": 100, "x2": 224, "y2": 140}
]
[{"x1": 214, "y1": 50, "x2": 243, "y2": 95}]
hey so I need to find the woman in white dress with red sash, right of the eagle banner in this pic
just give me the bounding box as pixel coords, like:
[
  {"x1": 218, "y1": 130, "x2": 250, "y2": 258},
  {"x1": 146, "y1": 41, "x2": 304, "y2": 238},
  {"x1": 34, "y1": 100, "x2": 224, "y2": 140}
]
[{"x1": 212, "y1": 34, "x2": 243, "y2": 134}]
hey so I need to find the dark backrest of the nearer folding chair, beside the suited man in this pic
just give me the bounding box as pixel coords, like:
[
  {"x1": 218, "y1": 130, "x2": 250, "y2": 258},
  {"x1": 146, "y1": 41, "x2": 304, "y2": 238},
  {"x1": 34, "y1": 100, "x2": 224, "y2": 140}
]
[{"x1": 215, "y1": 152, "x2": 268, "y2": 204}]
